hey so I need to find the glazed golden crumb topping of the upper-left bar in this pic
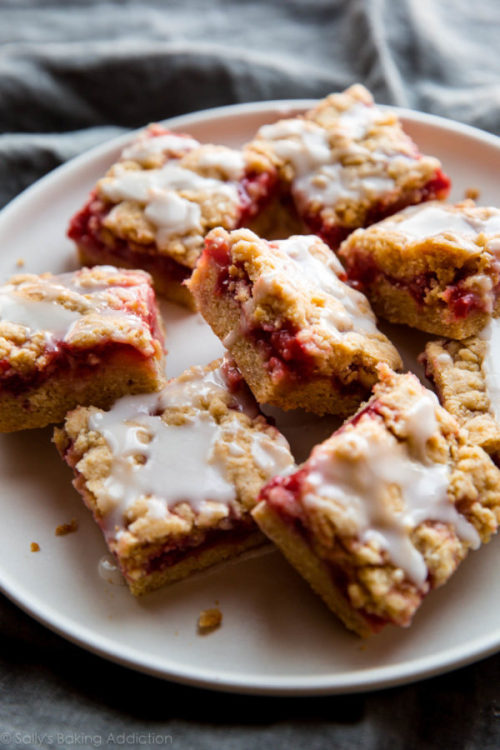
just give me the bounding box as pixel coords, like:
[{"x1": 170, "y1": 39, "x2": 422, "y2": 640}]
[{"x1": 97, "y1": 126, "x2": 270, "y2": 267}]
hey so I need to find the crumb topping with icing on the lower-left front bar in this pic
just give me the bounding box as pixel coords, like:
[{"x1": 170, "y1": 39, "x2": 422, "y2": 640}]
[{"x1": 58, "y1": 362, "x2": 293, "y2": 554}]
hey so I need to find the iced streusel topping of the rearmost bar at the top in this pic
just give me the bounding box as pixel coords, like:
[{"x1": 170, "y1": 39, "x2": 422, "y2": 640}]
[{"x1": 254, "y1": 85, "x2": 440, "y2": 223}]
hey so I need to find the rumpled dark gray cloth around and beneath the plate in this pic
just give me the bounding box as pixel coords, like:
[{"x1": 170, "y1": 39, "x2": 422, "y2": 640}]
[{"x1": 0, "y1": 0, "x2": 500, "y2": 750}]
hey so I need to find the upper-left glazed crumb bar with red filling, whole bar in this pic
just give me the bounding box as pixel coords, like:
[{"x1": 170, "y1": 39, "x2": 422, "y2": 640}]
[{"x1": 68, "y1": 125, "x2": 276, "y2": 305}]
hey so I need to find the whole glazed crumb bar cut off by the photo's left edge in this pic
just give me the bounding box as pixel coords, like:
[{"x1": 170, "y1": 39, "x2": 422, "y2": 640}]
[{"x1": 0, "y1": 266, "x2": 164, "y2": 432}]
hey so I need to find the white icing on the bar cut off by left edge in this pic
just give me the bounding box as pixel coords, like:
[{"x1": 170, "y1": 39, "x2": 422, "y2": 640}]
[{"x1": 0, "y1": 266, "x2": 148, "y2": 346}]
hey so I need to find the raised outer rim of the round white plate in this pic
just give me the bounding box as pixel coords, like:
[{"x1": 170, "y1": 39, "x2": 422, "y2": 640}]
[{"x1": 0, "y1": 99, "x2": 500, "y2": 696}]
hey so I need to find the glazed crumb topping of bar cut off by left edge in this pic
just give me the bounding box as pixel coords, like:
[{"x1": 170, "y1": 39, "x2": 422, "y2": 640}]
[{"x1": 0, "y1": 266, "x2": 158, "y2": 375}]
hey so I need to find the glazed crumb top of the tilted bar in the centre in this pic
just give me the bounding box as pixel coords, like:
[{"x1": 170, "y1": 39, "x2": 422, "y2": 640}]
[{"x1": 203, "y1": 229, "x2": 400, "y2": 372}]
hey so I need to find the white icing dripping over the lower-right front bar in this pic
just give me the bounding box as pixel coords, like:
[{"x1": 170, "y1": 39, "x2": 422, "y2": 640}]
[{"x1": 304, "y1": 393, "x2": 480, "y2": 586}]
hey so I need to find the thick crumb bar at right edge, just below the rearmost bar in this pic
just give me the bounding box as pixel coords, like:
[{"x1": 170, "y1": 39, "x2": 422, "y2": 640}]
[{"x1": 340, "y1": 201, "x2": 500, "y2": 339}]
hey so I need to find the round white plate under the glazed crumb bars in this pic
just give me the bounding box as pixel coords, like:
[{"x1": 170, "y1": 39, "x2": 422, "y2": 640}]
[{"x1": 0, "y1": 101, "x2": 500, "y2": 694}]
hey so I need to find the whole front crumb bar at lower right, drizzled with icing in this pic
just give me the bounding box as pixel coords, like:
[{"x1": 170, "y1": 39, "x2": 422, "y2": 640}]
[{"x1": 253, "y1": 368, "x2": 500, "y2": 636}]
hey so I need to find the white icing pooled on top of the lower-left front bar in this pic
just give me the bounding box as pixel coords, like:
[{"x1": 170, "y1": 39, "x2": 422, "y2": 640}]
[{"x1": 89, "y1": 369, "x2": 292, "y2": 538}]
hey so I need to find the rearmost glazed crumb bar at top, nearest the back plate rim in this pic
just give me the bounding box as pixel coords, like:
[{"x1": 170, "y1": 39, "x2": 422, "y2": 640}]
[{"x1": 249, "y1": 85, "x2": 450, "y2": 250}]
